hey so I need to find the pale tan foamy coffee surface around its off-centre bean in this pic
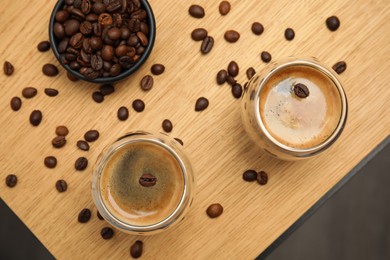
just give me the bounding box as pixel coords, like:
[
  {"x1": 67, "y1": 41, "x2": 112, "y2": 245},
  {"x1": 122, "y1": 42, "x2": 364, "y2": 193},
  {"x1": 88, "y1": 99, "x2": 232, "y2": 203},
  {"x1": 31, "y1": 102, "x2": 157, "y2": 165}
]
[{"x1": 259, "y1": 65, "x2": 342, "y2": 149}]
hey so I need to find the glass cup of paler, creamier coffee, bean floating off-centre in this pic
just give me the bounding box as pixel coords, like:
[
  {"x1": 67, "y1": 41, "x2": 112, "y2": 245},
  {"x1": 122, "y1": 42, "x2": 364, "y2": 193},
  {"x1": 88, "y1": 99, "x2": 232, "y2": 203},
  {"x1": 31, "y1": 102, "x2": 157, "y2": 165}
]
[{"x1": 241, "y1": 58, "x2": 348, "y2": 160}]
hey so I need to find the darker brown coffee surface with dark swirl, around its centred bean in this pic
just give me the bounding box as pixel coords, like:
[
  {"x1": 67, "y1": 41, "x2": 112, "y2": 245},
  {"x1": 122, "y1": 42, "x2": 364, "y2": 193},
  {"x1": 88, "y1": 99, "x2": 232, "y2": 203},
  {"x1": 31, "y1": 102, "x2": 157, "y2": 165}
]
[{"x1": 100, "y1": 141, "x2": 185, "y2": 226}]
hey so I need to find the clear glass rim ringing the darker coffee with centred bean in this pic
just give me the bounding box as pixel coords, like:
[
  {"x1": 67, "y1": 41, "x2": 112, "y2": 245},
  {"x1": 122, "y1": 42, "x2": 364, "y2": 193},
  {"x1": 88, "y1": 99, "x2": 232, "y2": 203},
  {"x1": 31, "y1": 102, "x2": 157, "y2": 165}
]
[{"x1": 92, "y1": 133, "x2": 190, "y2": 232}]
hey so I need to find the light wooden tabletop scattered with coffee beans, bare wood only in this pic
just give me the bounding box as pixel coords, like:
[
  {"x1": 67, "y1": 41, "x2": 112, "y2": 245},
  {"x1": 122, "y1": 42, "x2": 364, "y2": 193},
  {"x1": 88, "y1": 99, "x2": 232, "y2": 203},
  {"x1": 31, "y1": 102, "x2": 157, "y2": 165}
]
[{"x1": 0, "y1": 0, "x2": 390, "y2": 259}]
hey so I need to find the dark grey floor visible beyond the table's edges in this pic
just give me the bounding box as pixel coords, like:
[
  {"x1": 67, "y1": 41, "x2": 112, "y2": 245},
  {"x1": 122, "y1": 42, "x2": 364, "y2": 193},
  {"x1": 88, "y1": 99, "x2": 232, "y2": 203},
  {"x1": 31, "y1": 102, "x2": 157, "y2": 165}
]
[{"x1": 0, "y1": 141, "x2": 390, "y2": 260}]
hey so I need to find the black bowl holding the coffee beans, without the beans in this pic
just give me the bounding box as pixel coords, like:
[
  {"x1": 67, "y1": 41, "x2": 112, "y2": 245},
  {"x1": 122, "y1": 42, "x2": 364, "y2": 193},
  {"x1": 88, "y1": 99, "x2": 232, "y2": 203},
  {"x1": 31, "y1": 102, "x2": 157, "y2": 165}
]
[{"x1": 49, "y1": 0, "x2": 156, "y2": 84}]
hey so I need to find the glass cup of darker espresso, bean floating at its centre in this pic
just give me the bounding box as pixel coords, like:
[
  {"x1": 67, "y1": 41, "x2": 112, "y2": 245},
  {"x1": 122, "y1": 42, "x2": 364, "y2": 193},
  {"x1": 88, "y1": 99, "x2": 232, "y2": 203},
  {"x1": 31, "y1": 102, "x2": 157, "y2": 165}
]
[{"x1": 92, "y1": 131, "x2": 195, "y2": 235}]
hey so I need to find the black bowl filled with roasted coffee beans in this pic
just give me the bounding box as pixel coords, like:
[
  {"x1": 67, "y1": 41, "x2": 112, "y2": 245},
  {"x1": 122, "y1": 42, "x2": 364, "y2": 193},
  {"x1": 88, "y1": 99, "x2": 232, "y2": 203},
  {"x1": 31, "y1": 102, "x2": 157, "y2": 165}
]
[{"x1": 49, "y1": 0, "x2": 156, "y2": 84}]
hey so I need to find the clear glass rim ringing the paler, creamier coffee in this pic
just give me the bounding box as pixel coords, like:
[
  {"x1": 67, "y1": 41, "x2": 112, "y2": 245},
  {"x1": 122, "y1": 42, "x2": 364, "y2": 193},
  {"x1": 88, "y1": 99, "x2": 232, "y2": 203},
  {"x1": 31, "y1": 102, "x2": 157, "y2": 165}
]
[{"x1": 254, "y1": 58, "x2": 348, "y2": 154}]
